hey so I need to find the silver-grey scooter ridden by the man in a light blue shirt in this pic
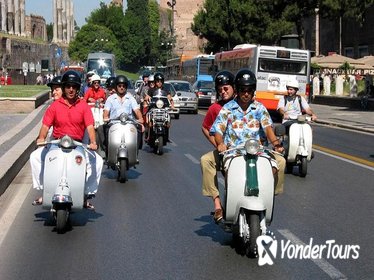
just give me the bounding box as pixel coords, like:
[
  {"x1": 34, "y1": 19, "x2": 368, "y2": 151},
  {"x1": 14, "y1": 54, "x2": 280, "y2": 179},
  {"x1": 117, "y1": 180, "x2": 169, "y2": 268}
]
[{"x1": 107, "y1": 113, "x2": 140, "y2": 183}]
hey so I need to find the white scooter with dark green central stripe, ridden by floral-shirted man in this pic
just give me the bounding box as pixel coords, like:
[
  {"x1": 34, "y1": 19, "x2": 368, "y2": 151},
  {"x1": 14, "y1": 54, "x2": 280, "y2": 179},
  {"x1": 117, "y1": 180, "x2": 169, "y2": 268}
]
[{"x1": 220, "y1": 137, "x2": 284, "y2": 257}]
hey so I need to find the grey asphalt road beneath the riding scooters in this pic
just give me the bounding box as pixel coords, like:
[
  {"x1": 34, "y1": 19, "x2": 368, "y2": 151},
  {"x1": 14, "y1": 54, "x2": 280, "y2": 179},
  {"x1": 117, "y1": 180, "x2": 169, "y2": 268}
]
[{"x1": 0, "y1": 112, "x2": 374, "y2": 280}]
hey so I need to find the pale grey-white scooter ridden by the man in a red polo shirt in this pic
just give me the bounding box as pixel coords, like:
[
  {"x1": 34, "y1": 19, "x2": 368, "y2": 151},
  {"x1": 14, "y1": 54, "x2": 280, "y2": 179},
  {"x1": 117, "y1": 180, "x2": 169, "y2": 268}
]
[{"x1": 39, "y1": 135, "x2": 91, "y2": 233}]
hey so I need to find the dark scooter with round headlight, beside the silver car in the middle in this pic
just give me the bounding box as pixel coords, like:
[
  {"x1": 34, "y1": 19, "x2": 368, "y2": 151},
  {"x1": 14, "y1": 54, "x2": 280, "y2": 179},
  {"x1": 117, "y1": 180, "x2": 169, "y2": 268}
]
[{"x1": 147, "y1": 95, "x2": 170, "y2": 155}]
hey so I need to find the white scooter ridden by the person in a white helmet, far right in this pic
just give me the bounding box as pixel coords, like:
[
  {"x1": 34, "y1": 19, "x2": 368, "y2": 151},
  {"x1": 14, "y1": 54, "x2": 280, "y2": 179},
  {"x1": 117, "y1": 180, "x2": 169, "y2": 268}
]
[{"x1": 283, "y1": 115, "x2": 313, "y2": 177}]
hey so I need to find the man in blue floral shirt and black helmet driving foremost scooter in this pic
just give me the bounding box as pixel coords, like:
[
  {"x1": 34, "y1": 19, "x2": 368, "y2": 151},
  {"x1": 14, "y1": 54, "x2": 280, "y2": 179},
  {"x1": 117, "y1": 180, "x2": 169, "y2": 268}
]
[{"x1": 210, "y1": 69, "x2": 286, "y2": 194}]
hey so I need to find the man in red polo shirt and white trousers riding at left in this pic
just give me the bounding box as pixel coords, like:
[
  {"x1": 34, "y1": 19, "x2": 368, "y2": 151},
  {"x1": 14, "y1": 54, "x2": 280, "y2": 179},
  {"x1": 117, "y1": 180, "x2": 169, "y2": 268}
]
[{"x1": 30, "y1": 70, "x2": 103, "y2": 209}]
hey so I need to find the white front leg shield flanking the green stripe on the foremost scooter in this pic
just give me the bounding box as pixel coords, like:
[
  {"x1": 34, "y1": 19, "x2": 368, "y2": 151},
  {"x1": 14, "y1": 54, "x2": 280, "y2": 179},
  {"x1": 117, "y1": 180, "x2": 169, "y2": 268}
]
[{"x1": 225, "y1": 156, "x2": 274, "y2": 222}]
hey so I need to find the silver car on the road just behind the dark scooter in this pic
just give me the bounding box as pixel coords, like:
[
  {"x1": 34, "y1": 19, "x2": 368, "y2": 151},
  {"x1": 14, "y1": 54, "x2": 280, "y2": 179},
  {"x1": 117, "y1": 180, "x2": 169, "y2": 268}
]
[{"x1": 167, "y1": 80, "x2": 198, "y2": 114}]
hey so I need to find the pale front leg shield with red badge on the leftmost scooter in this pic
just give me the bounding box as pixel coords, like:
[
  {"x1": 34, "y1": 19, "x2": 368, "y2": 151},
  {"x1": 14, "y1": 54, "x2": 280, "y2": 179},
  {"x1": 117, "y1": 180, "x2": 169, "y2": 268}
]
[{"x1": 43, "y1": 148, "x2": 86, "y2": 210}]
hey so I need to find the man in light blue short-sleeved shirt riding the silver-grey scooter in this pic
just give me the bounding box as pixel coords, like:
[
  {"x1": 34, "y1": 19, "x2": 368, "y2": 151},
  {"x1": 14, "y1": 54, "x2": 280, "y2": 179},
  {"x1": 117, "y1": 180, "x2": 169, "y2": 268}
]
[{"x1": 102, "y1": 75, "x2": 144, "y2": 155}]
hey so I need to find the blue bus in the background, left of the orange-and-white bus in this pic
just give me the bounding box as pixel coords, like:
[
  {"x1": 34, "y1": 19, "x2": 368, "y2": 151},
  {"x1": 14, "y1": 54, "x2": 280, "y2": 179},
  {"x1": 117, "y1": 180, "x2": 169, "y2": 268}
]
[{"x1": 182, "y1": 54, "x2": 214, "y2": 84}]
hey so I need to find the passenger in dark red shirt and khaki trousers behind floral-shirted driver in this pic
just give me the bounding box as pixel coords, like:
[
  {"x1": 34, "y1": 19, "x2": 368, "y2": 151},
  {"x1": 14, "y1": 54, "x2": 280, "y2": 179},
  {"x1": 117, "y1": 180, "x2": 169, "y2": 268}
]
[{"x1": 200, "y1": 70, "x2": 235, "y2": 223}]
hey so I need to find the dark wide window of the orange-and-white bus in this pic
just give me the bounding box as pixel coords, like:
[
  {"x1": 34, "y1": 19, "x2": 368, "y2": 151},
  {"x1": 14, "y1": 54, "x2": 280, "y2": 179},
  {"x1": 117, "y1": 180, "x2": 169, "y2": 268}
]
[{"x1": 258, "y1": 58, "x2": 308, "y2": 75}]
